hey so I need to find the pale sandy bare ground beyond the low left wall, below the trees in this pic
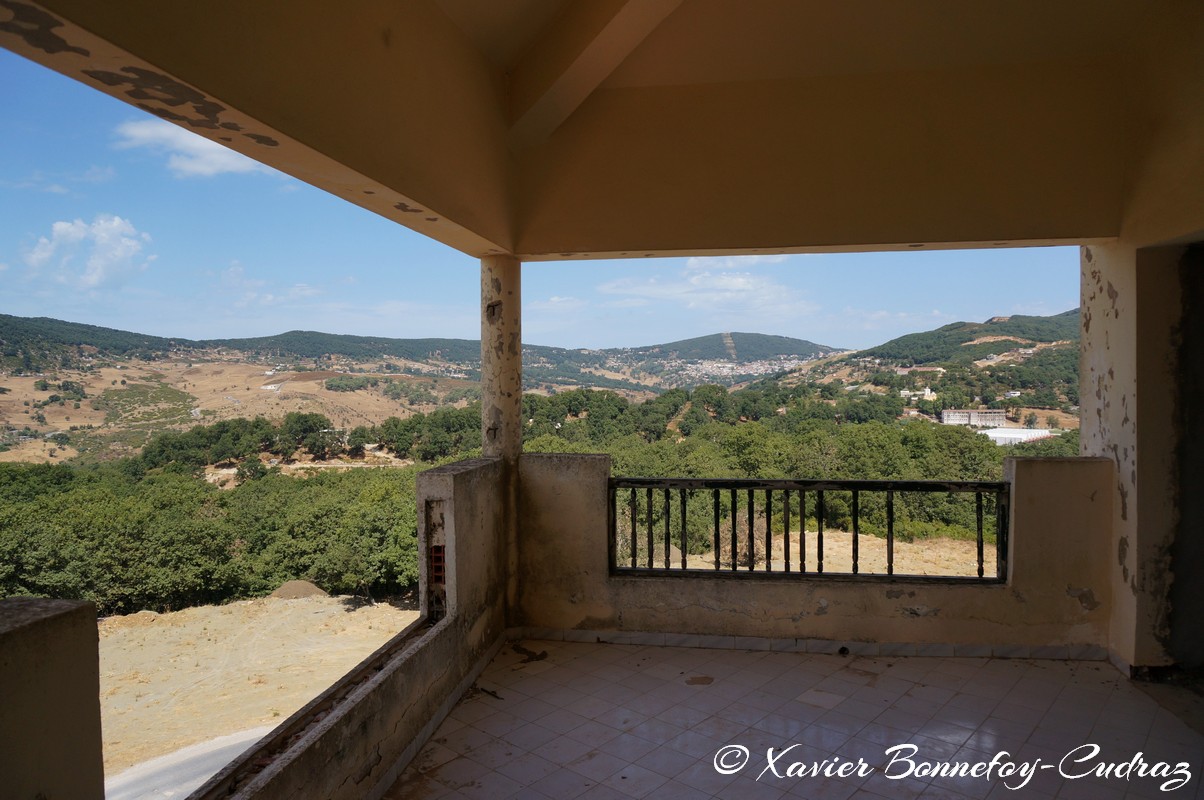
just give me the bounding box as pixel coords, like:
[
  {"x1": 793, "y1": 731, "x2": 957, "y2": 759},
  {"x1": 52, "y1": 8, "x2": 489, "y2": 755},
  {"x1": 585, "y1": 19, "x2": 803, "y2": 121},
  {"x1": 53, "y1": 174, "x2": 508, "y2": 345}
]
[{"x1": 100, "y1": 598, "x2": 418, "y2": 776}]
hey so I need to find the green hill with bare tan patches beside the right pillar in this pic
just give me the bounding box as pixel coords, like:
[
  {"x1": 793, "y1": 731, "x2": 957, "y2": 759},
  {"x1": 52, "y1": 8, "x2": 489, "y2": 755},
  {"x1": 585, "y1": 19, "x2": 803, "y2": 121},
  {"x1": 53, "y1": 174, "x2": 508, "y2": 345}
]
[{"x1": 860, "y1": 308, "x2": 1079, "y2": 366}]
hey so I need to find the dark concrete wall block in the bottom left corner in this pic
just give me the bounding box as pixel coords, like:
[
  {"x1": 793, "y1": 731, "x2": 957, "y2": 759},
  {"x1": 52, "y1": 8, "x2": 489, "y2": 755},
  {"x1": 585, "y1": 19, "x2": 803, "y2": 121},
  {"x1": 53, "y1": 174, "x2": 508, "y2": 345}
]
[{"x1": 0, "y1": 598, "x2": 105, "y2": 800}]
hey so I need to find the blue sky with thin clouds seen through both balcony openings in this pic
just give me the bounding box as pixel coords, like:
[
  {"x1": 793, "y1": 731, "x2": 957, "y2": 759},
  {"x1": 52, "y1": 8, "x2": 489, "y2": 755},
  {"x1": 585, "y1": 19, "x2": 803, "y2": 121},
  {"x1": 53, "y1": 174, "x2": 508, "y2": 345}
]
[{"x1": 0, "y1": 49, "x2": 1079, "y2": 347}]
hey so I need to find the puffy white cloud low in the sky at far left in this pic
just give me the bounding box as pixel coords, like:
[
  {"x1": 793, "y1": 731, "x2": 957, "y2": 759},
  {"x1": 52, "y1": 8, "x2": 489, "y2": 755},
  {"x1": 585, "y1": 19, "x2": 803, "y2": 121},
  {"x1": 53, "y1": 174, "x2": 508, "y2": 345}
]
[{"x1": 25, "y1": 214, "x2": 154, "y2": 290}]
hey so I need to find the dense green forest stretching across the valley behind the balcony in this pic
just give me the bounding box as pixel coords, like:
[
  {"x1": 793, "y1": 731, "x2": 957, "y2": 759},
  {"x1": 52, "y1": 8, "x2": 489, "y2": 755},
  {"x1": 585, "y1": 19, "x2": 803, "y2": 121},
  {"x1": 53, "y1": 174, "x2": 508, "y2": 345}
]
[{"x1": 0, "y1": 382, "x2": 1078, "y2": 613}]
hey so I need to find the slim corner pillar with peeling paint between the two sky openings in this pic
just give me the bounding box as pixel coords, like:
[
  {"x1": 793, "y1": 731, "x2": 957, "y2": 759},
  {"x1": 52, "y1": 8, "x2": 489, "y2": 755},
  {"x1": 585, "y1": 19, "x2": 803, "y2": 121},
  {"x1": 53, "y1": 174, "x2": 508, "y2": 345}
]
[{"x1": 480, "y1": 255, "x2": 523, "y2": 464}]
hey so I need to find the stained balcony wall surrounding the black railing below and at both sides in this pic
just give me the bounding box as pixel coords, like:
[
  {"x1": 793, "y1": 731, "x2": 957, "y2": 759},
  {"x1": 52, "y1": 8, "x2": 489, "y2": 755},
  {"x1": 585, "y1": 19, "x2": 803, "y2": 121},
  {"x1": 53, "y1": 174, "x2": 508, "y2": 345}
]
[{"x1": 512, "y1": 454, "x2": 1114, "y2": 651}]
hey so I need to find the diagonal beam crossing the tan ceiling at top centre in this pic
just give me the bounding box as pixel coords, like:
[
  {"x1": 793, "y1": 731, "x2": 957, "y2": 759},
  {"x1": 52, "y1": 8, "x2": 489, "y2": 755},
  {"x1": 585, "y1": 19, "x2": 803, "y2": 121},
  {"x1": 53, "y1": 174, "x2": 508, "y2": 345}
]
[{"x1": 508, "y1": 0, "x2": 681, "y2": 149}]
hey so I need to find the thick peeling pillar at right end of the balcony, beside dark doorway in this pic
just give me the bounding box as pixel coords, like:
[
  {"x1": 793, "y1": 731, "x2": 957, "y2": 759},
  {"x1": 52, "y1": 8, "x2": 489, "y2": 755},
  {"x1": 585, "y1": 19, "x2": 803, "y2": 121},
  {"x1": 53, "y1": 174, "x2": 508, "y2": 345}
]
[{"x1": 1079, "y1": 242, "x2": 1182, "y2": 666}]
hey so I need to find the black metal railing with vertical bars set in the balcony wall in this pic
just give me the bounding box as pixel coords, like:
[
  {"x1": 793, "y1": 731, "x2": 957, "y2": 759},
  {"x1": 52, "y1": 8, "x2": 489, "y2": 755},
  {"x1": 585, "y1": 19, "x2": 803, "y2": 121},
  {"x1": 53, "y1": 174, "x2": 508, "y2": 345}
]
[{"x1": 609, "y1": 477, "x2": 1009, "y2": 583}]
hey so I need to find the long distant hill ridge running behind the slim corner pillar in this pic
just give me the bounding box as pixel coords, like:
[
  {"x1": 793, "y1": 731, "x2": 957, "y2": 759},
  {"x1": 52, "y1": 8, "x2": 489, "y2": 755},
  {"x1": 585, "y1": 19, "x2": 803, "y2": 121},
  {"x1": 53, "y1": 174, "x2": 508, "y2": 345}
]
[{"x1": 0, "y1": 314, "x2": 834, "y2": 392}]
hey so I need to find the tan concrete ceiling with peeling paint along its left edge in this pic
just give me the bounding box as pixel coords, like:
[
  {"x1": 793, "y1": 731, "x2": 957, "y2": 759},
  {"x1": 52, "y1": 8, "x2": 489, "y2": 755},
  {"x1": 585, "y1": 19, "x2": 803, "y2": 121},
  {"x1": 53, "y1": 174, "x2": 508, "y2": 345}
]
[{"x1": 0, "y1": 0, "x2": 1204, "y2": 259}]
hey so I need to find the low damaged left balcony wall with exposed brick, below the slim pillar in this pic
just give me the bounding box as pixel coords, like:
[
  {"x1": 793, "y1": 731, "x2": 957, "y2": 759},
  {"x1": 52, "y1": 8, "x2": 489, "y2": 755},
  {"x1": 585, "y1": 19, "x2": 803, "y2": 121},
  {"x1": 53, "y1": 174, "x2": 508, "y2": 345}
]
[{"x1": 201, "y1": 459, "x2": 506, "y2": 800}]
